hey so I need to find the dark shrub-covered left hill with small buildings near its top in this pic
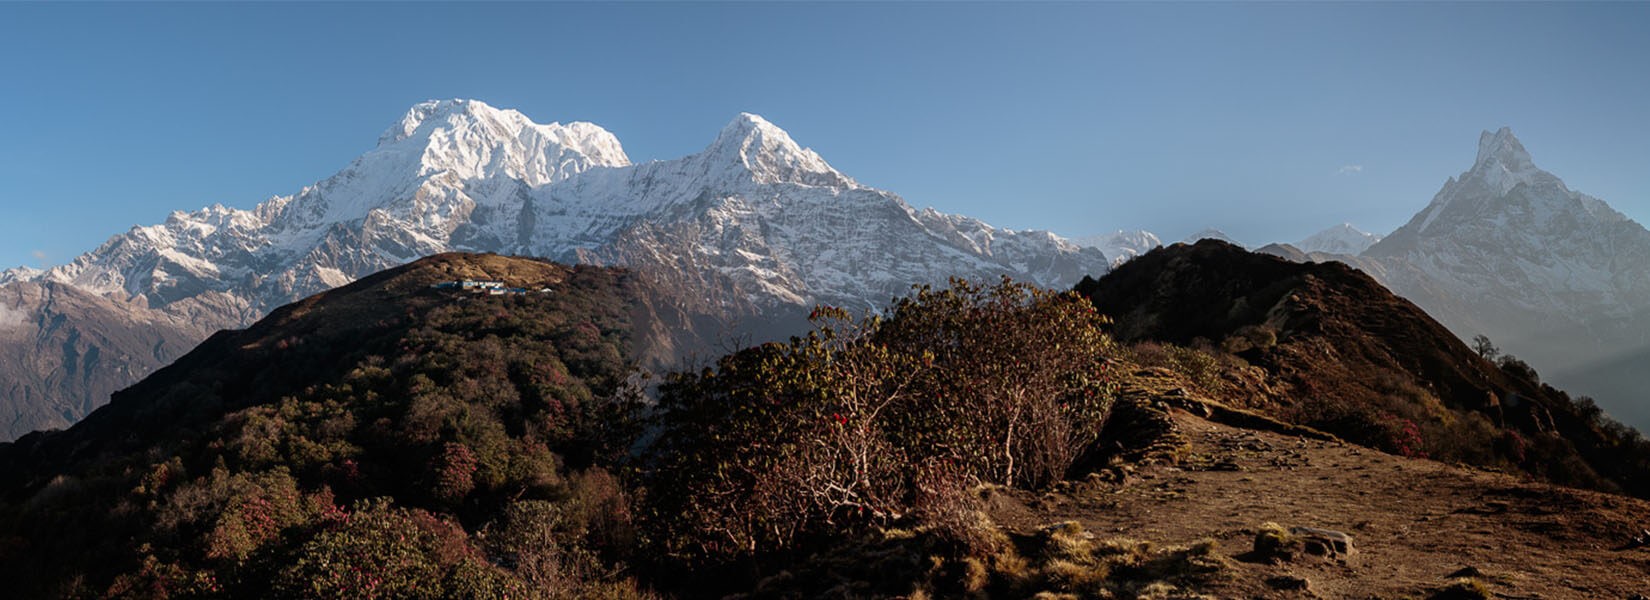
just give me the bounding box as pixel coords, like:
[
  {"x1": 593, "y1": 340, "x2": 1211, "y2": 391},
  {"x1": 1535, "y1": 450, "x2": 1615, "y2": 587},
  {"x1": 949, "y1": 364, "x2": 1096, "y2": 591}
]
[{"x1": 0, "y1": 254, "x2": 650, "y2": 597}]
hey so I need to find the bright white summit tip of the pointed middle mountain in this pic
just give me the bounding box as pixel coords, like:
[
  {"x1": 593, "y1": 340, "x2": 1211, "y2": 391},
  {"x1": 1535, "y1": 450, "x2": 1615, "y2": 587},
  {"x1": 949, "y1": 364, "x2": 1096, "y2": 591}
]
[{"x1": 700, "y1": 112, "x2": 858, "y2": 188}]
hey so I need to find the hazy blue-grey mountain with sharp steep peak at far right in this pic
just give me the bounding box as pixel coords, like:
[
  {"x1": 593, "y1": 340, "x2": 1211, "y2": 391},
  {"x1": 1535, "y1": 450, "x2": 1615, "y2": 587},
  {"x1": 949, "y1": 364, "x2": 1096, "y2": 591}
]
[{"x1": 1360, "y1": 129, "x2": 1650, "y2": 427}]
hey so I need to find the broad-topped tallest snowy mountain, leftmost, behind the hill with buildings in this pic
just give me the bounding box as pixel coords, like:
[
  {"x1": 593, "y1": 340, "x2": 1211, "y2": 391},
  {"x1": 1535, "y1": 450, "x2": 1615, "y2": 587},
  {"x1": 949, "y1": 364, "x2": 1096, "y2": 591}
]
[{"x1": 35, "y1": 101, "x2": 629, "y2": 316}]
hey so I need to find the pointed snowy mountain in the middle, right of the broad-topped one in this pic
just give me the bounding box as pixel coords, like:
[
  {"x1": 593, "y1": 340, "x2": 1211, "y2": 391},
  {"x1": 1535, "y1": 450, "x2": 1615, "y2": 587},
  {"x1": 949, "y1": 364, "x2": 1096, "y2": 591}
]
[{"x1": 547, "y1": 114, "x2": 1106, "y2": 308}]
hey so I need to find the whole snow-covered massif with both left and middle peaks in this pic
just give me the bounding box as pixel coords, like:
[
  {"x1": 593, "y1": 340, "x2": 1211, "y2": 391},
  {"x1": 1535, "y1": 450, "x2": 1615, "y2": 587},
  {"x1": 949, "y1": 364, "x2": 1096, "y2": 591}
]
[{"x1": 0, "y1": 101, "x2": 1107, "y2": 435}]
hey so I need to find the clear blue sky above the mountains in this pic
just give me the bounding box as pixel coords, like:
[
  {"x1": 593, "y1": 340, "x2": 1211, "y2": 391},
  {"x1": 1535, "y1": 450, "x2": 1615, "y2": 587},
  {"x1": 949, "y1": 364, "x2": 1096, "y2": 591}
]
[{"x1": 0, "y1": 3, "x2": 1650, "y2": 267}]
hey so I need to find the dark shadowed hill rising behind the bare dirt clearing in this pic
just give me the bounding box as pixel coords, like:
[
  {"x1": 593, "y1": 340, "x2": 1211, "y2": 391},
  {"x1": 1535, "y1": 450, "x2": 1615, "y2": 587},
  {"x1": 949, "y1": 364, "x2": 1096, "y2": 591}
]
[{"x1": 1077, "y1": 239, "x2": 1650, "y2": 496}]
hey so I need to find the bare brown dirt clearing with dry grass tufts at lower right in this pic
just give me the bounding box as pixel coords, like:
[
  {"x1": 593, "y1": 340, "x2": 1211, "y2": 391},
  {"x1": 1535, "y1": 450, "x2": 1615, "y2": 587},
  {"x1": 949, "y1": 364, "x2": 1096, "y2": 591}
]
[{"x1": 992, "y1": 410, "x2": 1650, "y2": 598}]
